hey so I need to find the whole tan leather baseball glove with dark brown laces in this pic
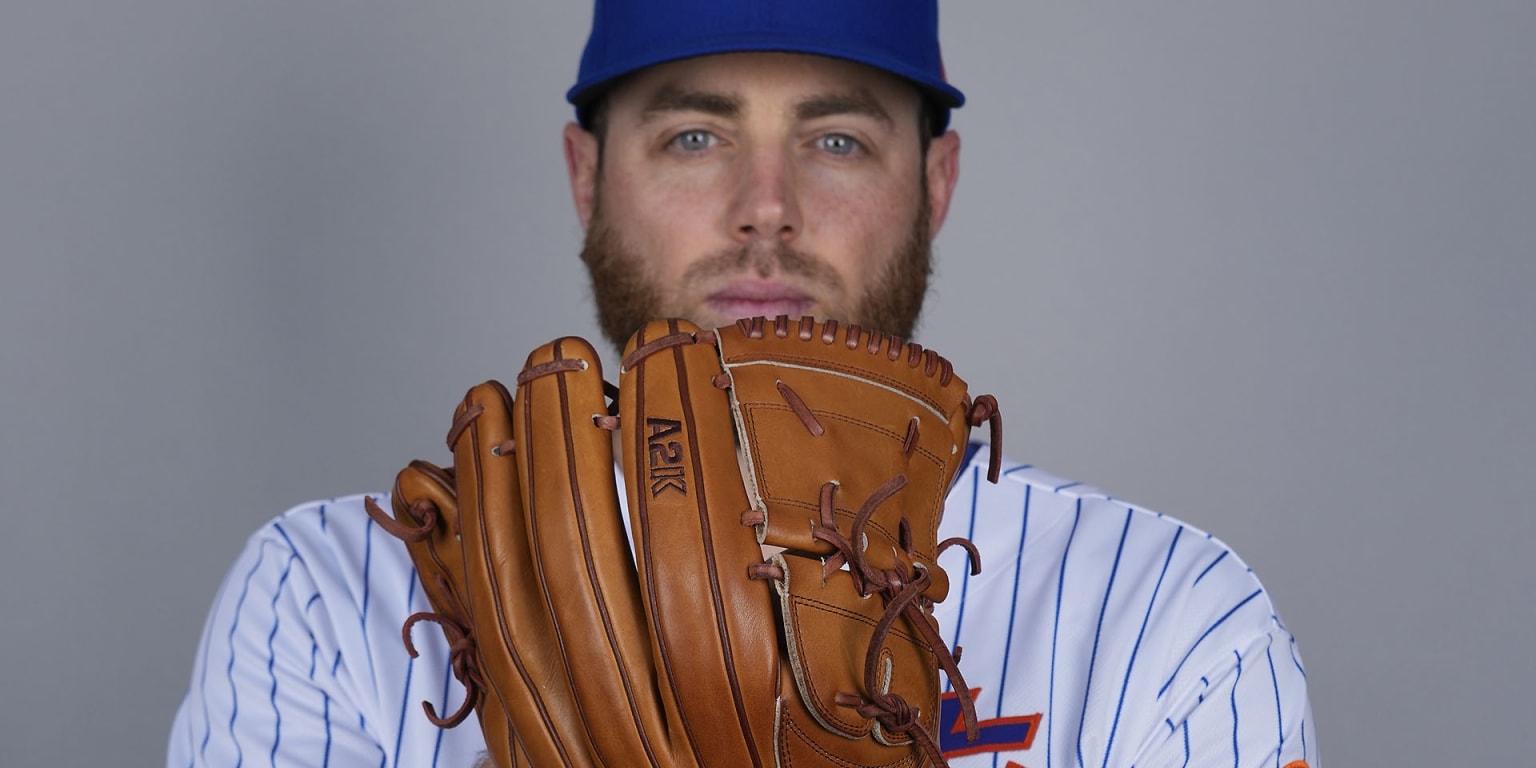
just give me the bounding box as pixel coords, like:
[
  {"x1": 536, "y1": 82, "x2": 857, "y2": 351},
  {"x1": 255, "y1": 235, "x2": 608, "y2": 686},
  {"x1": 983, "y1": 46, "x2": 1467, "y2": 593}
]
[{"x1": 369, "y1": 316, "x2": 1001, "y2": 768}]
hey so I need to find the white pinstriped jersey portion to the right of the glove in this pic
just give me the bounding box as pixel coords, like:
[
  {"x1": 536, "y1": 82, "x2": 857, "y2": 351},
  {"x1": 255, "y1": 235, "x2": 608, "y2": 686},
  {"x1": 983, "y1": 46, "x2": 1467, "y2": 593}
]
[{"x1": 934, "y1": 454, "x2": 1318, "y2": 768}]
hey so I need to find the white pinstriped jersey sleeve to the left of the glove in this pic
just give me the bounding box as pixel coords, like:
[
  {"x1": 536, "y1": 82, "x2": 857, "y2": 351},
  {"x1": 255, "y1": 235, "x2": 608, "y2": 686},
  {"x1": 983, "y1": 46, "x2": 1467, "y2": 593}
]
[{"x1": 166, "y1": 498, "x2": 484, "y2": 768}]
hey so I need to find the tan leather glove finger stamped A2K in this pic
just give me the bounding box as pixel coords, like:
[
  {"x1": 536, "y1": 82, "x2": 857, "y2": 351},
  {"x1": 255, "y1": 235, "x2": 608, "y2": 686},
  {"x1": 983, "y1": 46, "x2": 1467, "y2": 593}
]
[{"x1": 619, "y1": 319, "x2": 779, "y2": 768}]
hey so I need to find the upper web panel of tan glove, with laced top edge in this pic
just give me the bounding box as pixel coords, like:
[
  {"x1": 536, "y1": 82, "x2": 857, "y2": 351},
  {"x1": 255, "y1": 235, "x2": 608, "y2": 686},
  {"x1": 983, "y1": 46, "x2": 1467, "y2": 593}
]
[{"x1": 719, "y1": 318, "x2": 971, "y2": 571}]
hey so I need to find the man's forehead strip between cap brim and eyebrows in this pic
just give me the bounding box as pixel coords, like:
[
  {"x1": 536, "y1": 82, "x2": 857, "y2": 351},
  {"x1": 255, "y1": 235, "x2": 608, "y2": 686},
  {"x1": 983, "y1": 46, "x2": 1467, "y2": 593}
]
[{"x1": 608, "y1": 52, "x2": 922, "y2": 123}]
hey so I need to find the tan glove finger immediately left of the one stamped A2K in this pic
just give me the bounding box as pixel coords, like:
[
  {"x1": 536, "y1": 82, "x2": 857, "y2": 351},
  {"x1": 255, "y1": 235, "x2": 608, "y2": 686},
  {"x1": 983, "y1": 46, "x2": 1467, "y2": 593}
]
[{"x1": 513, "y1": 338, "x2": 671, "y2": 766}]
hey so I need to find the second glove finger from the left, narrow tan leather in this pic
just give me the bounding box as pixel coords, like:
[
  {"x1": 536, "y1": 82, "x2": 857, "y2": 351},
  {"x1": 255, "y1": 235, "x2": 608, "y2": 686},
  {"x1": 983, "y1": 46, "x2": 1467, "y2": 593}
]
[{"x1": 450, "y1": 381, "x2": 591, "y2": 766}]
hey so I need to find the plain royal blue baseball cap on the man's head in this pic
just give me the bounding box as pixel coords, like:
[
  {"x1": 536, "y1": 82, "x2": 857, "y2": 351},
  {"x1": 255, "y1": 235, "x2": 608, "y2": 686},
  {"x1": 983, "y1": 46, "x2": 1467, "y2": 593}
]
[{"x1": 565, "y1": 0, "x2": 965, "y2": 134}]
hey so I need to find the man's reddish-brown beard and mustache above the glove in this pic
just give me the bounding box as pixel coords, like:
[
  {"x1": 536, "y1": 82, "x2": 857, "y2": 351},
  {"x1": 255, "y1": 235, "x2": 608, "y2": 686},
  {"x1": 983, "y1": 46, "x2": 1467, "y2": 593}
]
[{"x1": 581, "y1": 195, "x2": 934, "y2": 350}]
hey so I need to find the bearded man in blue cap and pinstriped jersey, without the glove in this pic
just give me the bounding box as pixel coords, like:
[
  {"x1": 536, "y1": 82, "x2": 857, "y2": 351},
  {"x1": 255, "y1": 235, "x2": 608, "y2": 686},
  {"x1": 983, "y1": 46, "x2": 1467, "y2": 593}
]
[{"x1": 167, "y1": 0, "x2": 1318, "y2": 766}]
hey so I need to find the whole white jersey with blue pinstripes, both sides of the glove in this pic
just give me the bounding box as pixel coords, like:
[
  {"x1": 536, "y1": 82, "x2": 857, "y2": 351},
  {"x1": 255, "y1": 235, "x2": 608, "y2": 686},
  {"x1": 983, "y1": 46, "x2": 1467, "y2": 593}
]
[{"x1": 167, "y1": 447, "x2": 1318, "y2": 768}]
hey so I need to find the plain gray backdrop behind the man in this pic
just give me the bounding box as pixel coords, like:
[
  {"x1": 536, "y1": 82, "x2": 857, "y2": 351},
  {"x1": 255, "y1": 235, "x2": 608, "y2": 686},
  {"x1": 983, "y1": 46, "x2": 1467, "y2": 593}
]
[{"x1": 0, "y1": 0, "x2": 1536, "y2": 766}]
